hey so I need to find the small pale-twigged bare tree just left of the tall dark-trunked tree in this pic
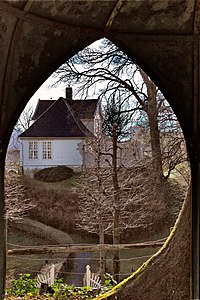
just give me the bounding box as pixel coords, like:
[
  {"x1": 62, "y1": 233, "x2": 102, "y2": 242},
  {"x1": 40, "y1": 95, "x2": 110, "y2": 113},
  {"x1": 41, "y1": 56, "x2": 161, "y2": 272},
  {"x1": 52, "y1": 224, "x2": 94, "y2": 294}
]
[{"x1": 77, "y1": 129, "x2": 112, "y2": 282}]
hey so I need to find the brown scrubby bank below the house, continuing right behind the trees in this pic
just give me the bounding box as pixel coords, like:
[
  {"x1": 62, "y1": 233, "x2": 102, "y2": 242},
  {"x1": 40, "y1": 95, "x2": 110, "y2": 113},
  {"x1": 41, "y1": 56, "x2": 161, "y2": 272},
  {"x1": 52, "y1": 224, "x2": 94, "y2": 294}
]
[{"x1": 21, "y1": 169, "x2": 188, "y2": 242}]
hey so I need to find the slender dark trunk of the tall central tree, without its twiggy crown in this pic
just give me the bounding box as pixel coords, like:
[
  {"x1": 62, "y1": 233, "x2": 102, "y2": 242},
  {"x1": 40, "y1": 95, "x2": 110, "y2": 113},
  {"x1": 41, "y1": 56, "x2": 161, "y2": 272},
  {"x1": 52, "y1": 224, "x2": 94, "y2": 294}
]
[{"x1": 112, "y1": 124, "x2": 120, "y2": 282}]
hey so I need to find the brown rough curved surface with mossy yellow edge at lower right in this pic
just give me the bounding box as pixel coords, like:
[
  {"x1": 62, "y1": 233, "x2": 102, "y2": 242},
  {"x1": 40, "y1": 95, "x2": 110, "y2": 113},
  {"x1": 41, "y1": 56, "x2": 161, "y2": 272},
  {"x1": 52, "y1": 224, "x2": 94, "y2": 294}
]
[{"x1": 117, "y1": 189, "x2": 191, "y2": 300}]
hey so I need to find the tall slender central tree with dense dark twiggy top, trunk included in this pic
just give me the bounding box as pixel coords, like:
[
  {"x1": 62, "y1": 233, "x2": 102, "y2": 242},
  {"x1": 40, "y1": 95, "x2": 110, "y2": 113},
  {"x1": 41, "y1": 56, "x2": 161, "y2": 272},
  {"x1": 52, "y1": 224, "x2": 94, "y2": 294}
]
[{"x1": 102, "y1": 93, "x2": 134, "y2": 281}]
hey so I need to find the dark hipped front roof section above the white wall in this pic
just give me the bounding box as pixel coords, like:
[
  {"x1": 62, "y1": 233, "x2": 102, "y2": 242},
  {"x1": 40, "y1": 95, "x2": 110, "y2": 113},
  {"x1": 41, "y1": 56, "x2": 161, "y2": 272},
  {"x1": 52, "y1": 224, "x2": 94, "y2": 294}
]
[{"x1": 19, "y1": 98, "x2": 91, "y2": 138}]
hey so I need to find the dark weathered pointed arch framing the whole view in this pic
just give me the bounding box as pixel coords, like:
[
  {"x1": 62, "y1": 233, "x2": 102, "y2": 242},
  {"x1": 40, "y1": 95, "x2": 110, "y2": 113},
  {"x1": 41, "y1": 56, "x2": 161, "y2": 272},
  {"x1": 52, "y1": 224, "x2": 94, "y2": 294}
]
[{"x1": 0, "y1": 0, "x2": 200, "y2": 299}]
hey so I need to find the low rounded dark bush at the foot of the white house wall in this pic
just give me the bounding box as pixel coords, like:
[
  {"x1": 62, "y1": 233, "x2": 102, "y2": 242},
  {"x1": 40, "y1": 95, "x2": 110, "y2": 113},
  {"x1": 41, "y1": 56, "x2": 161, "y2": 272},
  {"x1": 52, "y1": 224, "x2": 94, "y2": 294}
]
[{"x1": 34, "y1": 166, "x2": 74, "y2": 182}]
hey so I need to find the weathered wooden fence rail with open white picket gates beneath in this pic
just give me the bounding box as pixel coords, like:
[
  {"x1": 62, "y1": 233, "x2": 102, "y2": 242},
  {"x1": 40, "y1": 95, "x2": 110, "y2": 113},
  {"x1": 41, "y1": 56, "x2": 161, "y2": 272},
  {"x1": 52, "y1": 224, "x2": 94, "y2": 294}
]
[{"x1": 7, "y1": 240, "x2": 164, "y2": 288}]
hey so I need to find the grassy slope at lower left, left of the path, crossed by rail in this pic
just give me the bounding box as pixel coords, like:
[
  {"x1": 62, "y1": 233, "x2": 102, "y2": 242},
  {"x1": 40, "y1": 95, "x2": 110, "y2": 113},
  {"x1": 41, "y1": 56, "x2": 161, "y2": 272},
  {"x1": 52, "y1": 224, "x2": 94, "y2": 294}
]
[{"x1": 7, "y1": 221, "x2": 72, "y2": 286}]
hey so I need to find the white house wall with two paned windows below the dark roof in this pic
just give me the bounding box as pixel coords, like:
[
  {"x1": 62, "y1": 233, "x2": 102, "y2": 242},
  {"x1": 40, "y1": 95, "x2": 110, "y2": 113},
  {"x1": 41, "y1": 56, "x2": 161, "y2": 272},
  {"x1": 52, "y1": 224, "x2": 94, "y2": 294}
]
[{"x1": 20, "y1": 138, "x2": 84, "y2": 177}]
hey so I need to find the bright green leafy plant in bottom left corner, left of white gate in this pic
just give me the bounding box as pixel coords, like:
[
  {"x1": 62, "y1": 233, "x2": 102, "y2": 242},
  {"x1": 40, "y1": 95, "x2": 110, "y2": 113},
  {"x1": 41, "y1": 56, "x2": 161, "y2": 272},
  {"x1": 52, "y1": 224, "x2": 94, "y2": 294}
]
[{"x1": 6, "y1": 274, "x2": 39, "y2": 296}]
